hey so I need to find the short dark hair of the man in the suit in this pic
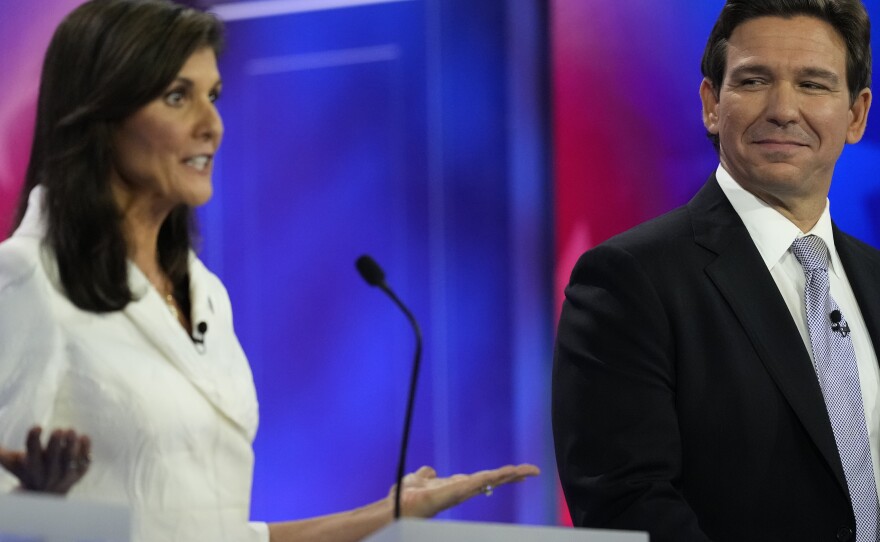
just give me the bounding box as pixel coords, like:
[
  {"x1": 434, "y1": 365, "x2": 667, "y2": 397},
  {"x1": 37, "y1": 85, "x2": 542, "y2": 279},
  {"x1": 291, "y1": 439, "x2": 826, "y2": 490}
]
[{"x1": 701, "y1": 0, "x2": 871, "y2": 151}]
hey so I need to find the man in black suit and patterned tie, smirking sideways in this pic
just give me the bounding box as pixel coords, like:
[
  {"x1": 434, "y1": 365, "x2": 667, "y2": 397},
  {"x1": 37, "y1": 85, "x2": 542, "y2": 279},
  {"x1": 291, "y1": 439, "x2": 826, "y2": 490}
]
[{"x1": 553, "y1": 0, "x2": 880, "y2": 542}]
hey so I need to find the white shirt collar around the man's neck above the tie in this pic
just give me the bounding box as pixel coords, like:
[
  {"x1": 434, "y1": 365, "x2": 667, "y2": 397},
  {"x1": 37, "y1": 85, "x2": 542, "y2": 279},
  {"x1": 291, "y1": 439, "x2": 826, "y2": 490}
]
[{"x1": 715, "y1": 164, "x2": 841, "y2": 275}]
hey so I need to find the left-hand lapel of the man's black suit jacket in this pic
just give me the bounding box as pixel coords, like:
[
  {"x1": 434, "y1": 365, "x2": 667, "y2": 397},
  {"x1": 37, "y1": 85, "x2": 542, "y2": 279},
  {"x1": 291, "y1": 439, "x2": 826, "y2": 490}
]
[{"x1": 688, "y1": 177, "x2": 844, "y2": 491}]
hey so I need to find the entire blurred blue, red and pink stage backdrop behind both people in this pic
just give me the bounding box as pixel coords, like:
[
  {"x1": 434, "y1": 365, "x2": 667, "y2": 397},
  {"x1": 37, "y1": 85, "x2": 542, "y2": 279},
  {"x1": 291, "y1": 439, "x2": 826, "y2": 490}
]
[{"x1": 0, "y1": 0, "x2": 880, "y2": 524}]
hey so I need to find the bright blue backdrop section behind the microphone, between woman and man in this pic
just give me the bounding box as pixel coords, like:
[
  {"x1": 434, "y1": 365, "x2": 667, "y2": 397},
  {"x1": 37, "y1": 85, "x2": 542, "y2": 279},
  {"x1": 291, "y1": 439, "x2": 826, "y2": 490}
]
[{"x1": 202, "y1": 0, "x2": 556, "y2": 523}]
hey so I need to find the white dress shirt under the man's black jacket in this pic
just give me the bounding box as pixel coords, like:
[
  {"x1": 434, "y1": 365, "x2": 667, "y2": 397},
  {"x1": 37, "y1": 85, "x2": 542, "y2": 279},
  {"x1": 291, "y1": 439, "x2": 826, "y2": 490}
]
[{"x1": 715, "y1": 165, "x2": 880, "y2": 502}]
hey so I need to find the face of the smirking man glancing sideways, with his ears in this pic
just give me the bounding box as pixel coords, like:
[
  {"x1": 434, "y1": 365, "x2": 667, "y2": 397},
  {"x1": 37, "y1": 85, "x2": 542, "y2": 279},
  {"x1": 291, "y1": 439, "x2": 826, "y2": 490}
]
[{"x1": 700, "y1": 16, "x2": 871, "y2": 218}]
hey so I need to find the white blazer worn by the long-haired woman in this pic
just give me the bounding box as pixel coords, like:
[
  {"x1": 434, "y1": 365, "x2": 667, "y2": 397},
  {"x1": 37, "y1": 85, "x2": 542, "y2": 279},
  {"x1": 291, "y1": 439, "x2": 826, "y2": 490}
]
[{"x1": 0, "y1": 187, "x2": 269, "y2": 542}]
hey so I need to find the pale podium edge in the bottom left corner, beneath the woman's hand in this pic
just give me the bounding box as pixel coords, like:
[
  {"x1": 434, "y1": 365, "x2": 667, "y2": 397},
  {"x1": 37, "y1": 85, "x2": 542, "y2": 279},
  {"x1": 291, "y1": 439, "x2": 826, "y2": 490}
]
[{"x1": 0, "y1": 493, "x2": 131, "y2": 542}]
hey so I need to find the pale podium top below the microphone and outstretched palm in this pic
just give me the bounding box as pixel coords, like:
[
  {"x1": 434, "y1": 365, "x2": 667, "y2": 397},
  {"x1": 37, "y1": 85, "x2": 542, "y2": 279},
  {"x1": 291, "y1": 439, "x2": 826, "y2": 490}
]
[{"x1": 364, "y1": 518, "x2": 648, "y2": 542}]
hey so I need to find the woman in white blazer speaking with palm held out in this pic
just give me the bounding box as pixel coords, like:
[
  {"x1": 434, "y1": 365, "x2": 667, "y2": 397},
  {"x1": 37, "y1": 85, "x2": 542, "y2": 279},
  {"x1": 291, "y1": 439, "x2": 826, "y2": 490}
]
[{"x1": 0, "y1": 0, "x2": 537, "y2": 542}]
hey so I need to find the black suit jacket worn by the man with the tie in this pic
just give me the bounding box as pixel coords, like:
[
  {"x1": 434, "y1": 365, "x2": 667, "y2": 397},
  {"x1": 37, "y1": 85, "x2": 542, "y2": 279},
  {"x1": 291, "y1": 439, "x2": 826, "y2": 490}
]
[{"x1": 553, "y1": 177, "x2": 880, "y2": 542}]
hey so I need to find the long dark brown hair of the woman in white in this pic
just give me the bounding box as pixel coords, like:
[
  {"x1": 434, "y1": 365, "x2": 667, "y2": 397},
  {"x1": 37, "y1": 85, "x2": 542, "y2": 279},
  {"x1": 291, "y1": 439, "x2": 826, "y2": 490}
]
[{"x1": 15, "y1": 0, "x2": 223, "y2": 312}]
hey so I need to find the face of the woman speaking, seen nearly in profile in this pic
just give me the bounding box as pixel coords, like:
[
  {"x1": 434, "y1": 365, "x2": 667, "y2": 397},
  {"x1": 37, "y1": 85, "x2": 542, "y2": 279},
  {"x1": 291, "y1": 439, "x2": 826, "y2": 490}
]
[{"x1": 111, "y1": 47, "x2": 223, "y2": 211}]
